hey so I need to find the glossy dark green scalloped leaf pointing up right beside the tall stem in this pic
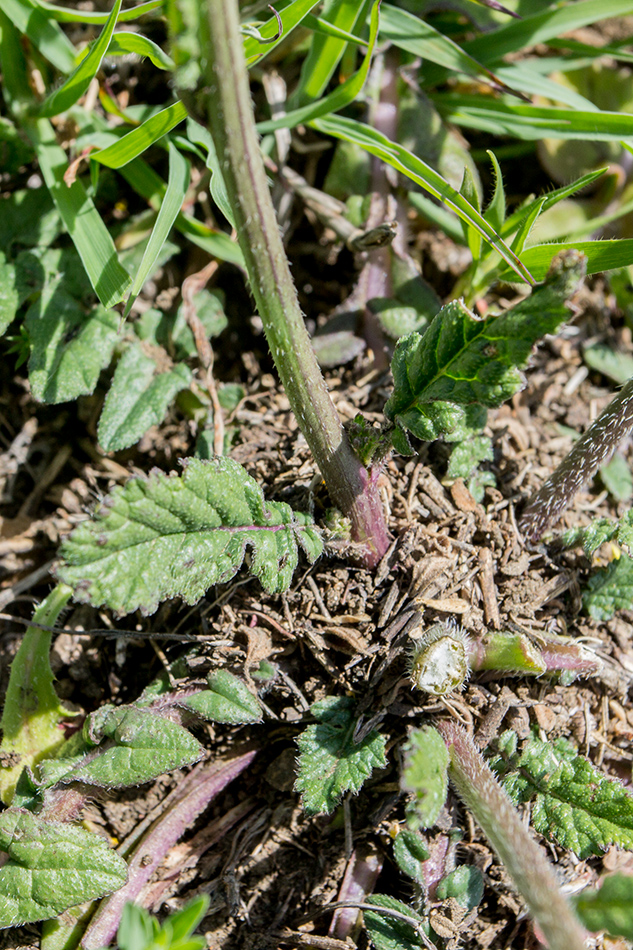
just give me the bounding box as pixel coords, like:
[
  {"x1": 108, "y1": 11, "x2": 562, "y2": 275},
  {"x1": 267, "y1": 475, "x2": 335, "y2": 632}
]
[{"x1": 385, "y1": 252, "x2": 584, "y2": 441}]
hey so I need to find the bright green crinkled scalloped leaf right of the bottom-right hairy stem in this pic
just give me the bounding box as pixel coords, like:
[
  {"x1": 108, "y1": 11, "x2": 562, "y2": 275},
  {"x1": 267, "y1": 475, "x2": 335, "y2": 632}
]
[{"x1": 491, "y1": 737, "x2": 633, "y2": 859}]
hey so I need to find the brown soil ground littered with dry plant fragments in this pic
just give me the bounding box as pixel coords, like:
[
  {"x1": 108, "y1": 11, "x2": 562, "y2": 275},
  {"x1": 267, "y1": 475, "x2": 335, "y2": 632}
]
[{"x1": 0, "y1": 223, "x2": 633, "y2": 950}]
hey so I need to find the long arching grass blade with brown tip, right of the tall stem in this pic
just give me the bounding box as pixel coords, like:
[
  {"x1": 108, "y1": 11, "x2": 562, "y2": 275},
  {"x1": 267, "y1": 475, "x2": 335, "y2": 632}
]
[{"x1": 310, "y1": 116, "x2": 535, "y2": 284}]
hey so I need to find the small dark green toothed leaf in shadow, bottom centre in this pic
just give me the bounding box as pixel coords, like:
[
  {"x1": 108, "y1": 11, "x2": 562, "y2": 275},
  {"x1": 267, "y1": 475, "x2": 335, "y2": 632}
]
[{"x1": 295, "y1": 696, "x2": 386, "y2": 815}]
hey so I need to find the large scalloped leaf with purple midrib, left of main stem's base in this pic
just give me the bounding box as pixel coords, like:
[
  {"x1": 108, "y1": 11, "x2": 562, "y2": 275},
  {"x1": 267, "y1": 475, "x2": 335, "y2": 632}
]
[{"x1": 57, "y1": 458, "x2": 323, "y2": 614}]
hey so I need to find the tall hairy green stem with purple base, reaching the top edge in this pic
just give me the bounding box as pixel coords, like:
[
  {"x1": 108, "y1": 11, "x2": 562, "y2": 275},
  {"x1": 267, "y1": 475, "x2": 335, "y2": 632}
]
[{"x1": 195, "y1": 0, "x2": 389, "y2": 567}]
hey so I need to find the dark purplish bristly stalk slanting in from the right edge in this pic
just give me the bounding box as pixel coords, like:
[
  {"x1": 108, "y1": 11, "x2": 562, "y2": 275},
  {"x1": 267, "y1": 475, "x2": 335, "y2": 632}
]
[{"x1": 519, "y1": 379, "x2": 633, "y2": 541}]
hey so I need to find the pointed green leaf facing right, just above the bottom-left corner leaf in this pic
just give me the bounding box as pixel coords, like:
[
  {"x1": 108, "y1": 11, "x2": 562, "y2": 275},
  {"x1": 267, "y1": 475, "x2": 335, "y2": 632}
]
[{"x1": 50, "y1": 705, "x2": 204, "y2": 788}]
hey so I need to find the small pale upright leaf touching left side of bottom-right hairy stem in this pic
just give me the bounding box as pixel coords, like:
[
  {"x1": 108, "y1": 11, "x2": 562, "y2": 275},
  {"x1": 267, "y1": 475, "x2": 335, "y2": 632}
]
[{"x1": 401, "y1": 726, "x2": 449, "y2": 828}]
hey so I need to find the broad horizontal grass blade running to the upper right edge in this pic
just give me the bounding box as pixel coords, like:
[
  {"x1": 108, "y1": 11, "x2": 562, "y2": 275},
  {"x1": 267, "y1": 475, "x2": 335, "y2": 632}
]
[{"x1": 432, "y1": 92, "x2": 633, "y2": 142}]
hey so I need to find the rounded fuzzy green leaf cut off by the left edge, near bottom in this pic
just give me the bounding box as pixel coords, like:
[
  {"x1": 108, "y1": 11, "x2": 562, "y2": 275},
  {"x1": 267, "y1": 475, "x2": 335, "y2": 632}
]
[{"x1": 0, "y1": 808, "x2": 127, "y2": 927}]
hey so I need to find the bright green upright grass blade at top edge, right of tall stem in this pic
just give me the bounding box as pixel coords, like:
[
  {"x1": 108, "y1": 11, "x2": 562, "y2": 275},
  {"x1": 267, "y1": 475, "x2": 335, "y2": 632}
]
[{"x1": 293, "y1": 0, "x2": 371, "y2": 105}]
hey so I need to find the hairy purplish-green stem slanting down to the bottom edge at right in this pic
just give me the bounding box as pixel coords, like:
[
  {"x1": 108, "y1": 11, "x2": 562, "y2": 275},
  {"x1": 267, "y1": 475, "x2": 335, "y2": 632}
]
[{"x1": 438, "y1": 722, "x2": 585, "y2": 950}]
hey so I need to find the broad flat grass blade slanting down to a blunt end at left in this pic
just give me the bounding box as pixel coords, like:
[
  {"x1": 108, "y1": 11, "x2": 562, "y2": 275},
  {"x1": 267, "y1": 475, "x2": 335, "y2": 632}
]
[{"x1": 24, "y1": 119, "x2": 130, "y2": 308}]
